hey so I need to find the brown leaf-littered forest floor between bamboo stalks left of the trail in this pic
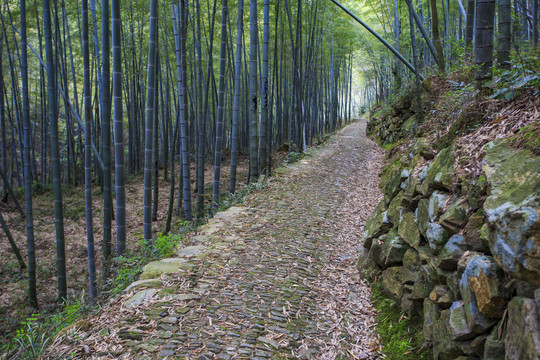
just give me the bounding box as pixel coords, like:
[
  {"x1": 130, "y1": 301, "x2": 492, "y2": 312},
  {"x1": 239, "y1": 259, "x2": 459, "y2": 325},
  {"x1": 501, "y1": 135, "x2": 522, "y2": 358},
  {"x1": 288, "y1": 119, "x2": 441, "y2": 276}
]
[{"x1": 0, "y1": 142, "x2": 287, "y2": 344}]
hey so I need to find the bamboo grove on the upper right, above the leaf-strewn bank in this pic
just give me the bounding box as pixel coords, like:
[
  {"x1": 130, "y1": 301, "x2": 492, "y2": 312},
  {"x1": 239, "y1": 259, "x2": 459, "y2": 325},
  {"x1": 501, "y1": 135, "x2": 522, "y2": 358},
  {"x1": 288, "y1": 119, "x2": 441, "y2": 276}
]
[{"x1": 353, "y1": 0, "x2": 540, "y2": 104}]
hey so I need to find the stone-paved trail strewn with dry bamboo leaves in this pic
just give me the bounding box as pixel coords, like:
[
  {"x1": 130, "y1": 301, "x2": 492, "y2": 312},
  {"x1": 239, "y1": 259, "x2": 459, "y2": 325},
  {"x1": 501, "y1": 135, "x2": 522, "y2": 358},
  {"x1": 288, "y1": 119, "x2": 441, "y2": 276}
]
[{"x1": 49, "y1": 122, "x2": 382, "y2": 360}]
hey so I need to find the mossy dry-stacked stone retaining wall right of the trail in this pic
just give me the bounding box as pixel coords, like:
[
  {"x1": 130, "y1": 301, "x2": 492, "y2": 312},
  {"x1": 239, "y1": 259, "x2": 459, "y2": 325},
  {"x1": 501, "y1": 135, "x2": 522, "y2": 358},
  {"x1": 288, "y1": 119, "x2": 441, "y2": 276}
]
[{"x1": 358, "y1": 130, "x2": 540, "y2": 360}]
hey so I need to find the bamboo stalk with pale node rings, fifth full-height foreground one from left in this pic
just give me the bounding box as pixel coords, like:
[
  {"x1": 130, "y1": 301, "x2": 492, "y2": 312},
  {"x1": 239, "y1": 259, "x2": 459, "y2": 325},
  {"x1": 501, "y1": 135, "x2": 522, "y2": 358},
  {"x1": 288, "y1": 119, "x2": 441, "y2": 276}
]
[{"x1": 111, "y1": 0, "x2": 126, "y2": 256}]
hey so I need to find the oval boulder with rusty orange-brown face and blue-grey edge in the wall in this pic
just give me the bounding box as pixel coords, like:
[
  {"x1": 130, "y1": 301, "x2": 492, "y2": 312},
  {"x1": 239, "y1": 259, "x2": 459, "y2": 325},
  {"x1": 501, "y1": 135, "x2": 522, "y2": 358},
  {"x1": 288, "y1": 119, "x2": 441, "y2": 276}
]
[{"x1": 459, "y1": 255, "x2": 506, "y2": 334}]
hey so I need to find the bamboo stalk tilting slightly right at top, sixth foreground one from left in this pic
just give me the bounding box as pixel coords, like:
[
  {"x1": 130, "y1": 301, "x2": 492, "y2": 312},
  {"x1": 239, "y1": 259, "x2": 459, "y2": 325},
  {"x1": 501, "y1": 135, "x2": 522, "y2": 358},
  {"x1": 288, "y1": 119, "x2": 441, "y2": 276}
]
[{"x1": 143, "y1": 0, "x2": 158, "y2": 247}]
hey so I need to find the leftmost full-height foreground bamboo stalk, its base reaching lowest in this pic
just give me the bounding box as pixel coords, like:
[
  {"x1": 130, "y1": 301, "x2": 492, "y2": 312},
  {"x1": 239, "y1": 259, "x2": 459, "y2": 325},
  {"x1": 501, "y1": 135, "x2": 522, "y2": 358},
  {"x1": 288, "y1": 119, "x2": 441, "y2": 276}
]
[{"x1": 20, "y1": 0, "x2": 38, "y2": 308}]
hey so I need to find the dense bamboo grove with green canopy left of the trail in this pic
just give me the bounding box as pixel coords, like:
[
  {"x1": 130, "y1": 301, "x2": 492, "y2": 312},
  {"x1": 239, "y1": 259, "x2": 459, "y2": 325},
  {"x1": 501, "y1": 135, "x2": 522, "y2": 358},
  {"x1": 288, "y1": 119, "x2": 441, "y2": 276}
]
[{"x1": 0, "y1": 0, "x2": 356, "y2": 307}]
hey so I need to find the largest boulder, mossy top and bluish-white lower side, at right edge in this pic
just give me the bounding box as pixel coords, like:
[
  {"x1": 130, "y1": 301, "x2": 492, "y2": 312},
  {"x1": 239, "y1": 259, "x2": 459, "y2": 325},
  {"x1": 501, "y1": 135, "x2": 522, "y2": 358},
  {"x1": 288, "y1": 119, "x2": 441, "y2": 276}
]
[{"x1": 483, "y1": 140, "x2": 540, "y2": 287}]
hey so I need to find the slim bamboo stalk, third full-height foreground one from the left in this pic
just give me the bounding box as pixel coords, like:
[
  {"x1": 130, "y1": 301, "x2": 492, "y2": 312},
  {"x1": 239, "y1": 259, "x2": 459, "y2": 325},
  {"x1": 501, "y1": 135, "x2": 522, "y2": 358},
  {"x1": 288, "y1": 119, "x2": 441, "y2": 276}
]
[{"x1": 82, "y1": 0, "x2": 97, "y2": 300}]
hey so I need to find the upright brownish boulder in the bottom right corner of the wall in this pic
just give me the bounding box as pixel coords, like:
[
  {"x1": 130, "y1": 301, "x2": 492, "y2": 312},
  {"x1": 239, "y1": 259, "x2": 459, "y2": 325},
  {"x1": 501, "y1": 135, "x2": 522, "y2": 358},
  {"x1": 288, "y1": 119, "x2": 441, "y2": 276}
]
[{"x1": 505, "y1": 297, "x2": 540, "y2": 360}]
